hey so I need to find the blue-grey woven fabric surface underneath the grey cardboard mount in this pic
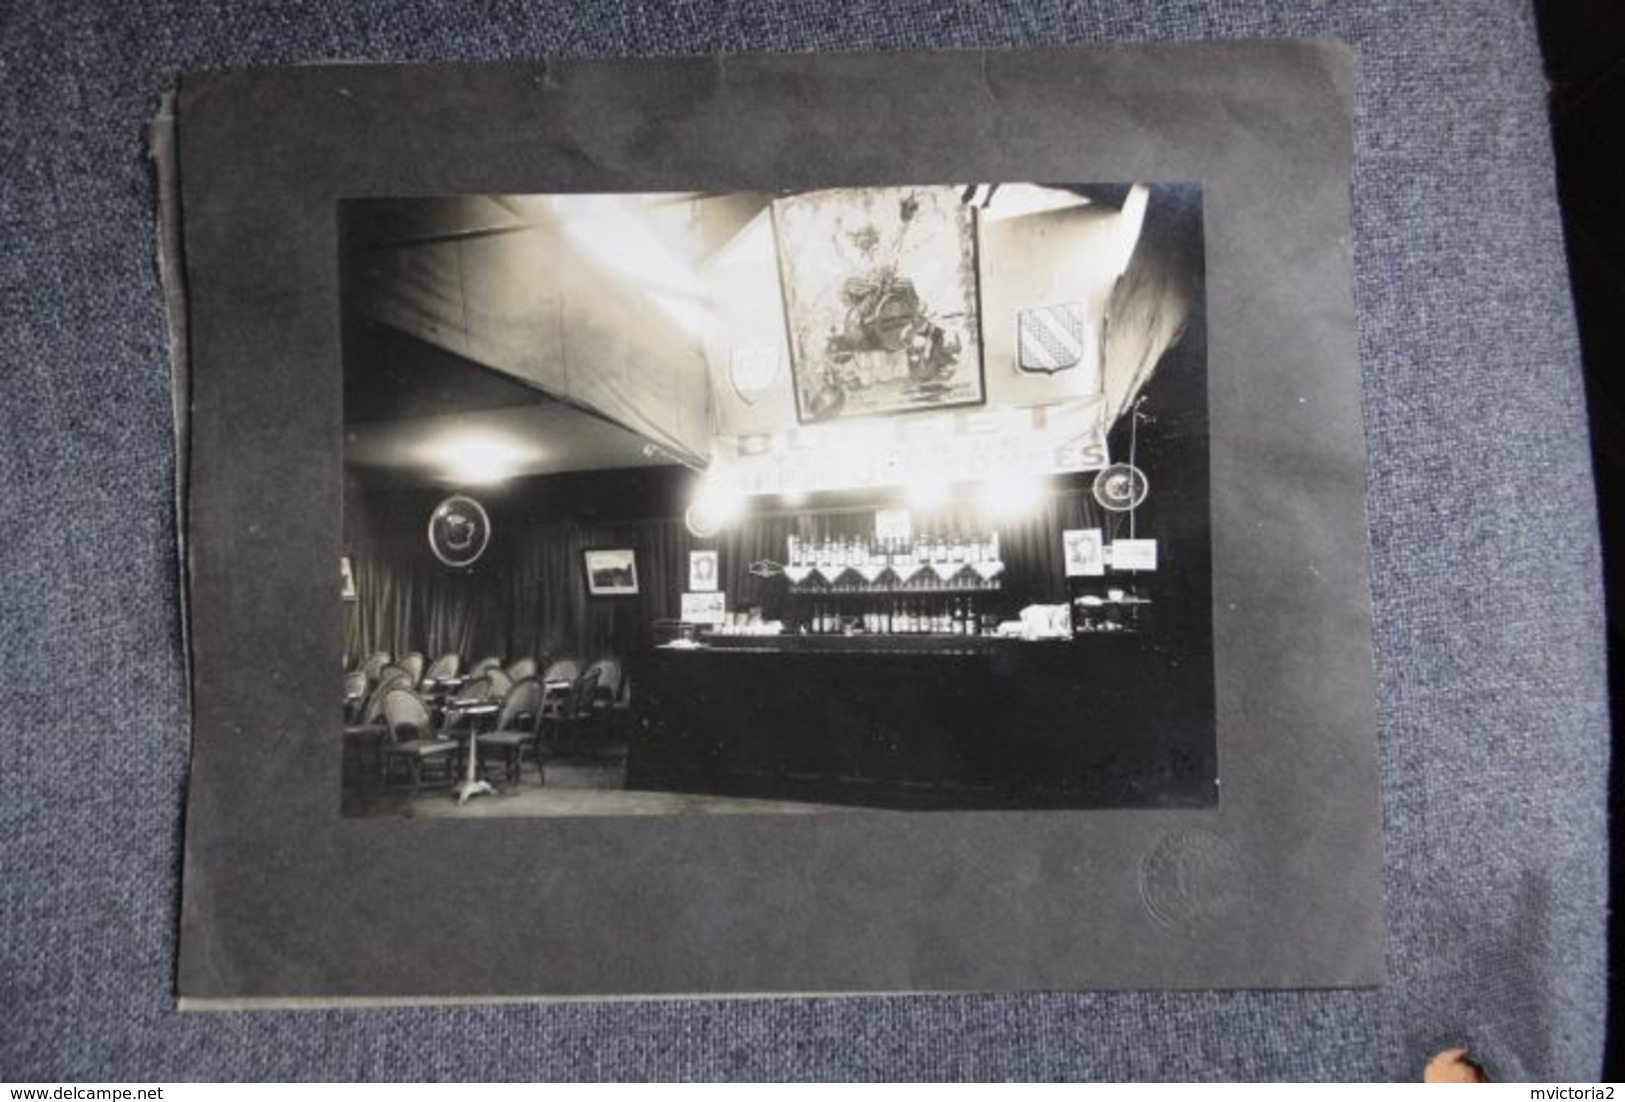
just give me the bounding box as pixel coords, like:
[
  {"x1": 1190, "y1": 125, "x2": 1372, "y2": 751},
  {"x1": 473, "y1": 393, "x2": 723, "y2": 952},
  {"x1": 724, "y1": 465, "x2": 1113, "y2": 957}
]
[{"x1": 0, "y1": 0, "x2": 1607, "y2": 1081}]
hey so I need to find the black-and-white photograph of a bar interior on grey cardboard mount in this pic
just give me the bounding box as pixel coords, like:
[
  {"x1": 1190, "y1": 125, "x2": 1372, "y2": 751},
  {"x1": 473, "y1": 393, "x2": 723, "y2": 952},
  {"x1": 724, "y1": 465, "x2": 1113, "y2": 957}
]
[{"x1": 333, "y1": 182, "x2": 1219, "y2": 818}]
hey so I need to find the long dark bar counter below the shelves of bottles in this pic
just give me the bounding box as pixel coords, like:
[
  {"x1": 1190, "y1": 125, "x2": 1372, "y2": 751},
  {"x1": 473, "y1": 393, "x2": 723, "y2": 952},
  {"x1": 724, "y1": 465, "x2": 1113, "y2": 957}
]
[{"x1": 627, "y1": 632, "x2": 1217, "y2": 809}]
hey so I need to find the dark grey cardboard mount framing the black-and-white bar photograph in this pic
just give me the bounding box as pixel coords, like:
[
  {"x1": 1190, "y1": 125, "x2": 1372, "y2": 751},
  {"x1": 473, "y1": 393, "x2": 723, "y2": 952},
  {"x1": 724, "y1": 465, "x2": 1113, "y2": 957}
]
[{"x1": 176, "y1": 41, "x2": 1385, "y2": 1006}]
